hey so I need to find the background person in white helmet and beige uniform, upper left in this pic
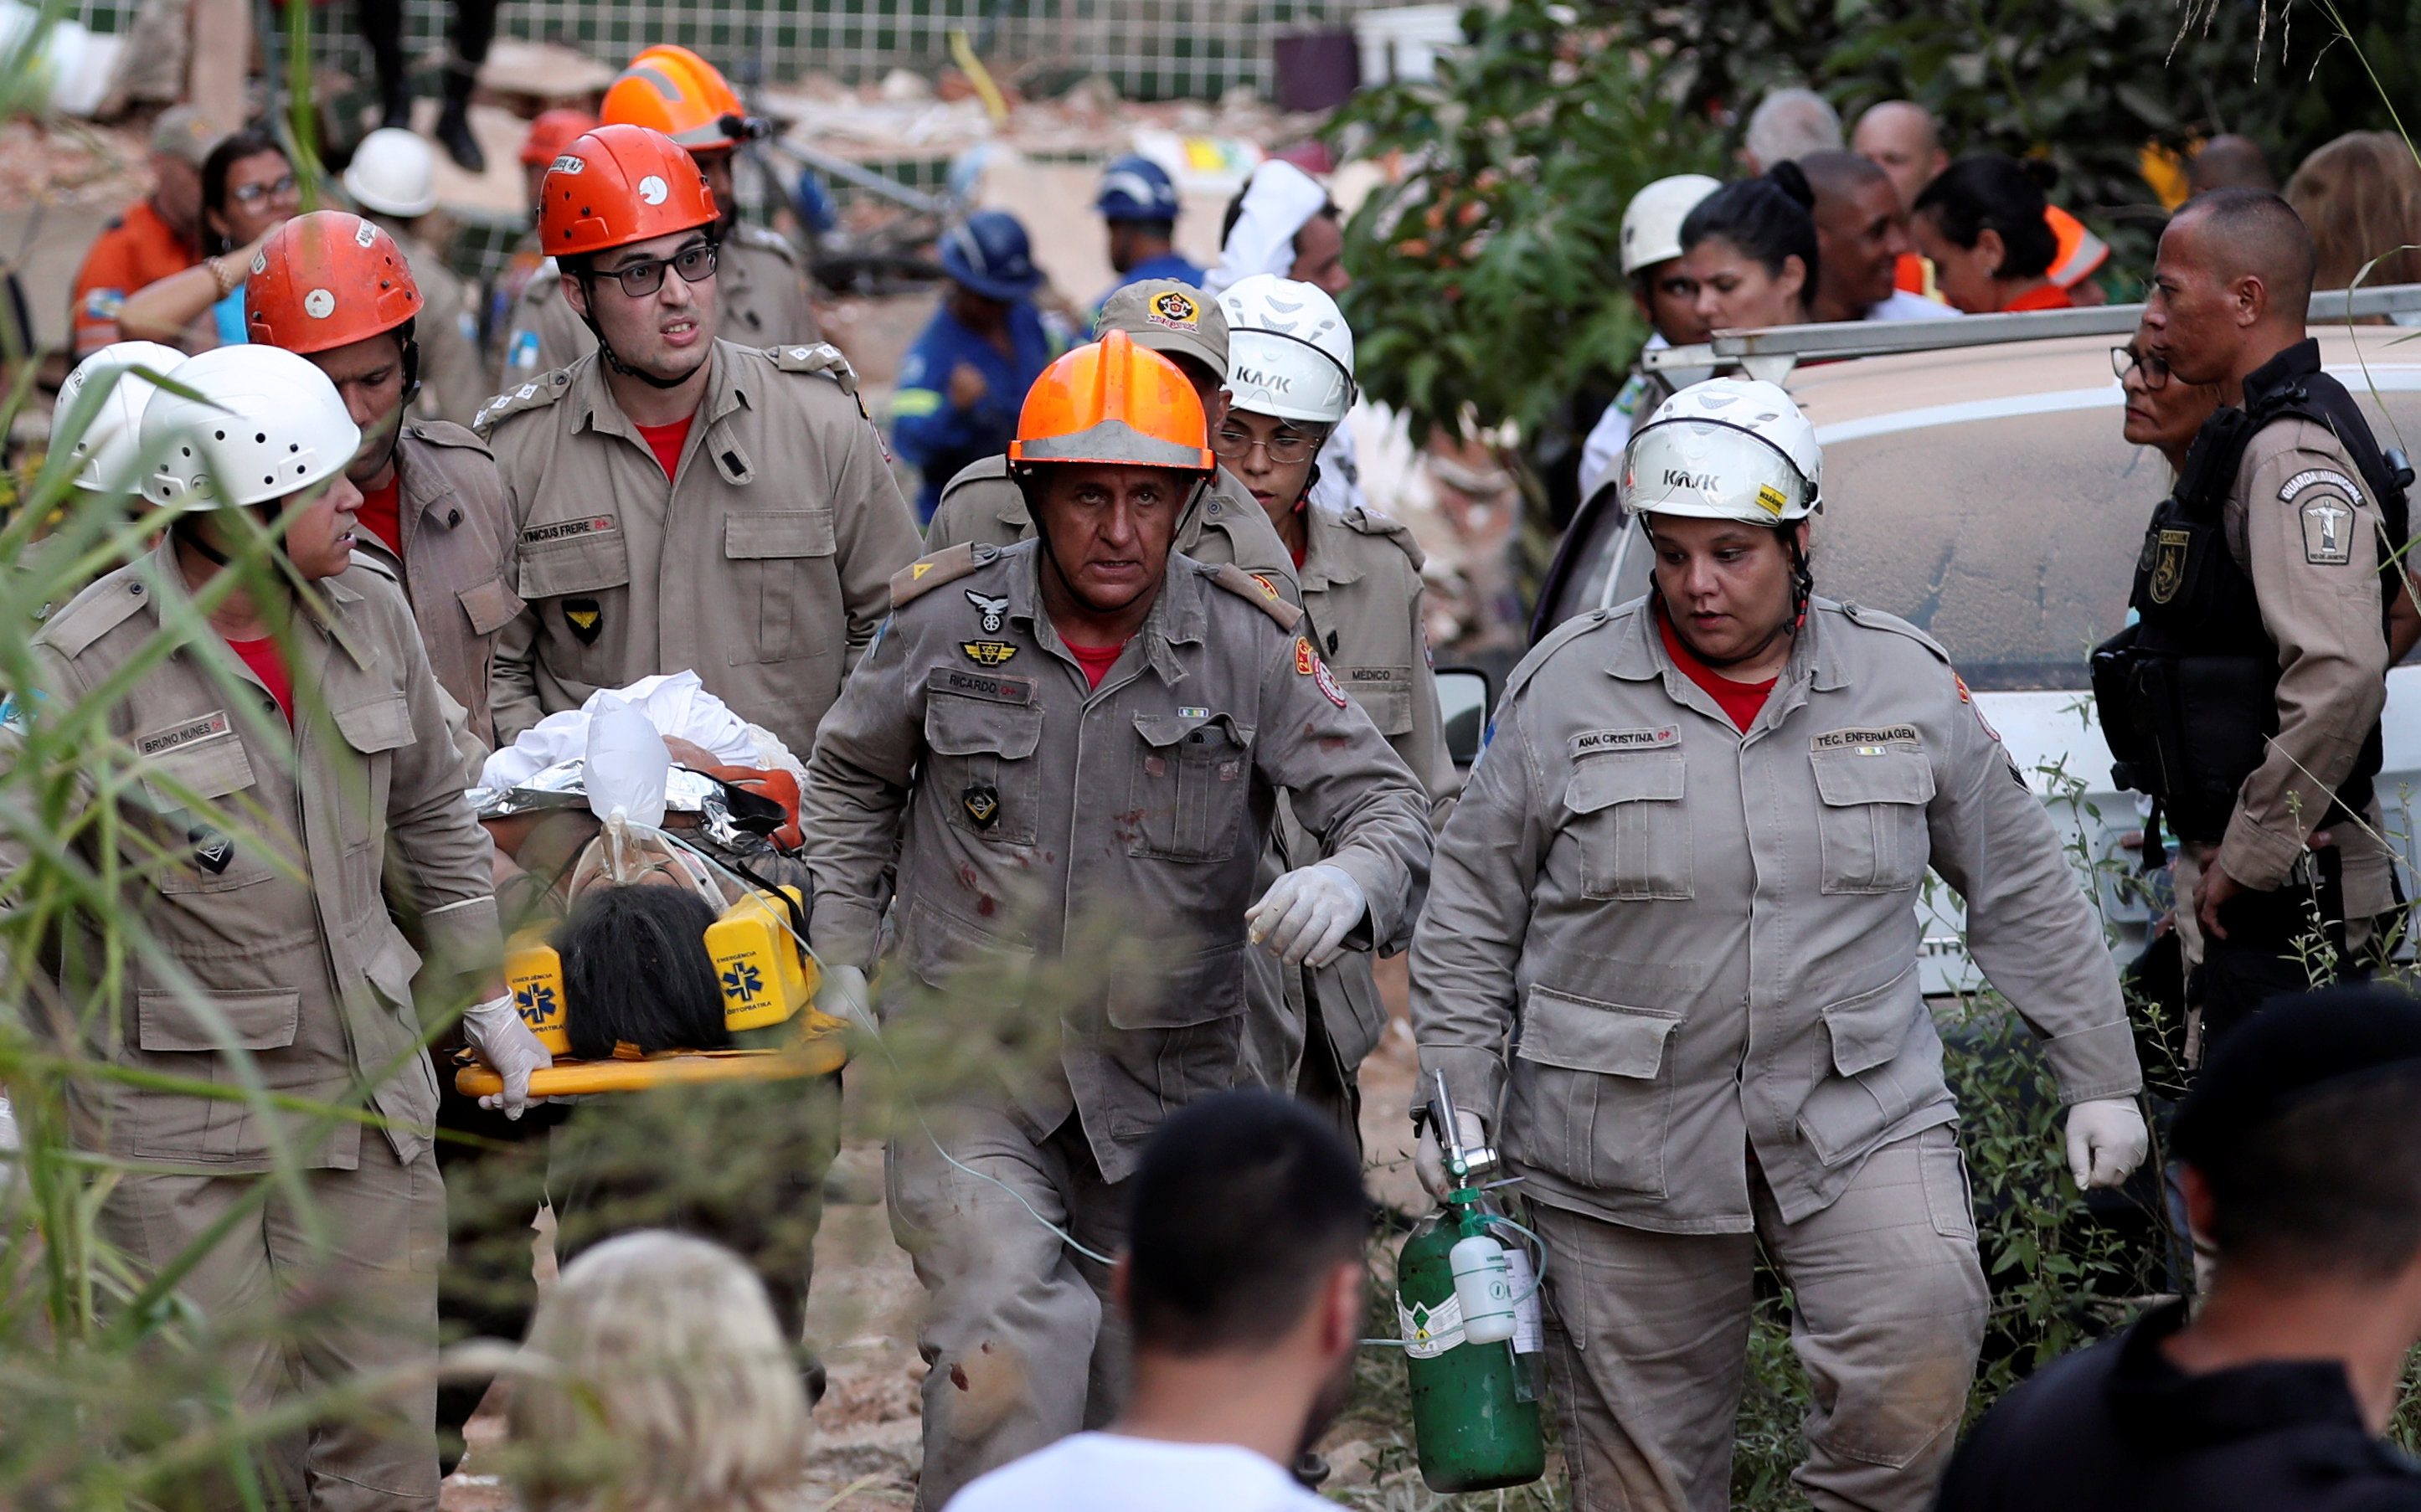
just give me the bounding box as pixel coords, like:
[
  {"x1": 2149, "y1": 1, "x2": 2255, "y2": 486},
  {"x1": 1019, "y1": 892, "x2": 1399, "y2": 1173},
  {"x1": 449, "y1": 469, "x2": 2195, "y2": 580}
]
[{"x1": 344, "y1": 126, "x2": 497, "y2": 426}]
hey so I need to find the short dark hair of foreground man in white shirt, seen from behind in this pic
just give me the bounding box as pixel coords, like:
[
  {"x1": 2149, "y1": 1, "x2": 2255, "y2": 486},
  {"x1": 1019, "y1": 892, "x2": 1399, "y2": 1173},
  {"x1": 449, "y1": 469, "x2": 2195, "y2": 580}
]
[{"x1": 1126, "y1": 1091, "x2": 1370, "y2": 1355}]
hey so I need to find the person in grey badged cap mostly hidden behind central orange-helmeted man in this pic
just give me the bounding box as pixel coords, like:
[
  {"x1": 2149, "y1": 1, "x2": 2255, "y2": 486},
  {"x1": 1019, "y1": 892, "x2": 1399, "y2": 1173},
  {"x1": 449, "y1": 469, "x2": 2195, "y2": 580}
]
[{"x1": 925, "y1": 278, "x2": 1302, "y2": 603}]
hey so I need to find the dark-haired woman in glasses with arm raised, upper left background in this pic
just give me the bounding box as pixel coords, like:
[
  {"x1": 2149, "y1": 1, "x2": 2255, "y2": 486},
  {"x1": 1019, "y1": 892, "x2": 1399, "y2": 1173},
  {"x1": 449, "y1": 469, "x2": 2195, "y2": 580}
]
[{"x1": 119, "y1": 131, "x2": 302, "y2": 351}]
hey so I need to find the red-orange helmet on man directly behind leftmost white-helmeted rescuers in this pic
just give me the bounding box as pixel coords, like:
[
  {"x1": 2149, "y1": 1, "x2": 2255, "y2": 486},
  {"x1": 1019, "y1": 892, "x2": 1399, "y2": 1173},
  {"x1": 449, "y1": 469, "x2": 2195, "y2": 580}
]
[{"x1": 245, "y1": 210, "x2": 421, "y2": 353}]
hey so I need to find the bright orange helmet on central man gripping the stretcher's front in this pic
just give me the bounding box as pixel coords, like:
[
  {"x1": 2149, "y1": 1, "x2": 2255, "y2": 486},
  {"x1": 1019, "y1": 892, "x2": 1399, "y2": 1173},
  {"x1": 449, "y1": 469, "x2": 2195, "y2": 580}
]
[{"x1": 1010, "y1": 332, "x2": 1218, "y2": 471}]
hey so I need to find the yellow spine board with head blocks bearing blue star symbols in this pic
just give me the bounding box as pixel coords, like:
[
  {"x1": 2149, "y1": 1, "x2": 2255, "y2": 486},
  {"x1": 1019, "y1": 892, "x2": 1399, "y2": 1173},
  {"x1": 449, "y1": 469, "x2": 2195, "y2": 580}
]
[{"x1": 456, "y1": 887, "x2": 850, "y2": 1098}]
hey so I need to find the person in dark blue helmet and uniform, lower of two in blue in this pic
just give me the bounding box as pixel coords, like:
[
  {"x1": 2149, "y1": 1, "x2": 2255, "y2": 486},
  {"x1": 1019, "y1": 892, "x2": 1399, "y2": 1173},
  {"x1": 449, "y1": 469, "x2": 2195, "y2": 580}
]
[{"x1": 891, "y1": 210, "x2": 1063, "y2": 520}]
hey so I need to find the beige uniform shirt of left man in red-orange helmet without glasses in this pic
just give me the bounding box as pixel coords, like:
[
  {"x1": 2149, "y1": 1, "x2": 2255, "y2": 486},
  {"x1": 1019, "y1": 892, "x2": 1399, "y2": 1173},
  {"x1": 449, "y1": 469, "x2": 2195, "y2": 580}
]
[{"x1": 353, "y1": 421, "x2": 521, "y2": 748}]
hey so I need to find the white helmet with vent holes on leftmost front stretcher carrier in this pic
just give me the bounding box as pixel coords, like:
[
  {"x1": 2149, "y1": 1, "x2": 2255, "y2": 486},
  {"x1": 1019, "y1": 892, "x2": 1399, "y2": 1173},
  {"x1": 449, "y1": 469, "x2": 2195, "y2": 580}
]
[{"x1": 143, "y1": 346, "x2": 361, "y2": 508}]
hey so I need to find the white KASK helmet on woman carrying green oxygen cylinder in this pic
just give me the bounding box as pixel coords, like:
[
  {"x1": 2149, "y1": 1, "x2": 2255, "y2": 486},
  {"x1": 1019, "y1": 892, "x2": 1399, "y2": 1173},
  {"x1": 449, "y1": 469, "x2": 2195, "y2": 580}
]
[{"x1": 1622, "y1": 378, "x2": 1823, "y2": 525}]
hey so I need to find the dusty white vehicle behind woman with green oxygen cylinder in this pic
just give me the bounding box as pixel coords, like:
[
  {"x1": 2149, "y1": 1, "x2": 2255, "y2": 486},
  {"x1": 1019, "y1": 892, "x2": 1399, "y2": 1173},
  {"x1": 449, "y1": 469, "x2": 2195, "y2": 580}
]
[{"x1": 1532, "y1": 305, "x2": 2421, "y2": 995}]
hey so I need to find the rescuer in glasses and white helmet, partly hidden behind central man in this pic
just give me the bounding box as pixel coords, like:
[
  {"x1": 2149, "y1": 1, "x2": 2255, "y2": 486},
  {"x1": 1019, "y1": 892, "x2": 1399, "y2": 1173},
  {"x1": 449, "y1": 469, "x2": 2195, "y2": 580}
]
[{"x1": 1229, "y1": 274, "x2": 1462, "y2": 1149}]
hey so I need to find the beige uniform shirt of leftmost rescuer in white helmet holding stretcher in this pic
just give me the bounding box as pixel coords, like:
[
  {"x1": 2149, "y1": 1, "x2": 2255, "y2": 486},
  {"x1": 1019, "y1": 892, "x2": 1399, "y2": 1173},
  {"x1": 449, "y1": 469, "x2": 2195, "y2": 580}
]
[{"x1": 33, "y1": 544, "x2": 503, "y2": 1171}]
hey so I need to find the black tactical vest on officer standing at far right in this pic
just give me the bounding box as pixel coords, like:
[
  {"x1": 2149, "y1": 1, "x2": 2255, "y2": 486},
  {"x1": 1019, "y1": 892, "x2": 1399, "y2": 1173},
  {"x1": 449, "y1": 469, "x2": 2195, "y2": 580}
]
[{"x1": 2092, "y1": 341, "x2": 2411, "y2": 849}]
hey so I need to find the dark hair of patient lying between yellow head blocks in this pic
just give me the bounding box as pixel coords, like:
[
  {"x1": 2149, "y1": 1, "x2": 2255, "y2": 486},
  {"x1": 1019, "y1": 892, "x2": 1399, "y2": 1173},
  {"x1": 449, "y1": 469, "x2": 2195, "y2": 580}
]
[{"x1": 554, "y1": 886, "x2": 731, "y2": 1060}]
